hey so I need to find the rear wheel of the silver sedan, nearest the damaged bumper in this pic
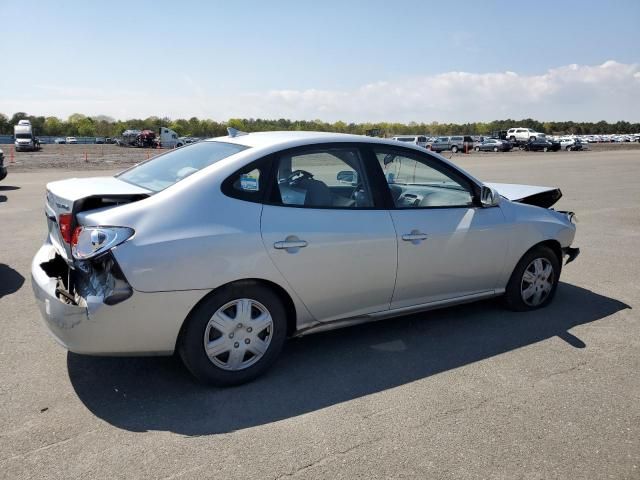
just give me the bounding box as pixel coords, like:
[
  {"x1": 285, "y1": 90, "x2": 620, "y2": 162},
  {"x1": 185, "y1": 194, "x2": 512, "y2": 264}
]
[{"x1": 178, "y1": 282, "x2": 287, "y2": 386}]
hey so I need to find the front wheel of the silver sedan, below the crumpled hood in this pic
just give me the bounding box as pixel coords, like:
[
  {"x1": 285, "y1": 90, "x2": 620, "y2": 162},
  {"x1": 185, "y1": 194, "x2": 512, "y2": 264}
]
[{"x1": 504, "y1": 245, "x2": 562, "y2": 312}]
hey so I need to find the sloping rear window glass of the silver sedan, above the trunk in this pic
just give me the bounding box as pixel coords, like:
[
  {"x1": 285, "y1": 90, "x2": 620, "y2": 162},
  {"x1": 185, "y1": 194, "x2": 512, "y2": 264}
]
[{"x1": 117, "y1": 142, "x2": 249, "y2": 192}]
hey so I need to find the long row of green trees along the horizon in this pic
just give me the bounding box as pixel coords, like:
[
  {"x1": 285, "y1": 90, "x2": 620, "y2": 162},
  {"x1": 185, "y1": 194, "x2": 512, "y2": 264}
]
[{"x1": 0, "y1": 112, "x2": 640, "y2": 137}]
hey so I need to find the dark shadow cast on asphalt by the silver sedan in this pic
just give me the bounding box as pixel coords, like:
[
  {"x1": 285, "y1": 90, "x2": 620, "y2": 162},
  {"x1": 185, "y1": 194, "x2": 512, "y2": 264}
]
[{"x1": 67, "y1": 283, "x2": 630, "y2": 435}]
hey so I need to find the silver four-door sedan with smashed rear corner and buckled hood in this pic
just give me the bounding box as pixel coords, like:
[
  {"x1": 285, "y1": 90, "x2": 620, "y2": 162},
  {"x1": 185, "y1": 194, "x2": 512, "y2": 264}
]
[{"x1": 32, "y1": 130, "x2": 578, "y2": 385}]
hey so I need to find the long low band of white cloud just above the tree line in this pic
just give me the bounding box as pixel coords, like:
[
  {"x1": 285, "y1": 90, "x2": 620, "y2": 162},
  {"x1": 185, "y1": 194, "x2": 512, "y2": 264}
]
[{"x1": 0, "y1": 60, "x2": 640, "y2": 122}]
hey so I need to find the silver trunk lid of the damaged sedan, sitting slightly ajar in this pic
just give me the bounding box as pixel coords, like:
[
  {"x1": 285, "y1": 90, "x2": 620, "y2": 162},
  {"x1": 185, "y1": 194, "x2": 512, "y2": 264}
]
[{"x1": 45, "y1": 177, "x2": 153, "y2": 263}]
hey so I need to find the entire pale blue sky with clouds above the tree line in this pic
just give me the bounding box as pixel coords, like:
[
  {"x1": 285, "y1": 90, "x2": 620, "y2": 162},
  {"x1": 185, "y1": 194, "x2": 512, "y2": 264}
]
[{"x1": 0, "y1": 0, "x2": 640, "y2": 121}]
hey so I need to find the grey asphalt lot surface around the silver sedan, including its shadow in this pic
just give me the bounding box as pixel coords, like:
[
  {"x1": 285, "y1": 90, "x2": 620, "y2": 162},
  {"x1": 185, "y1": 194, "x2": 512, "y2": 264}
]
[{"x1": 0, "y1": 150, "x2": 640, "y2": 480}]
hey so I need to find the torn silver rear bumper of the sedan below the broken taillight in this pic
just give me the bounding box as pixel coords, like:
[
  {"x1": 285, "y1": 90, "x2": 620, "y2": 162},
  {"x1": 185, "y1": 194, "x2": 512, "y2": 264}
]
[{"x1": 31, "y1": 242, "x2": 208, "y2": 355}]
